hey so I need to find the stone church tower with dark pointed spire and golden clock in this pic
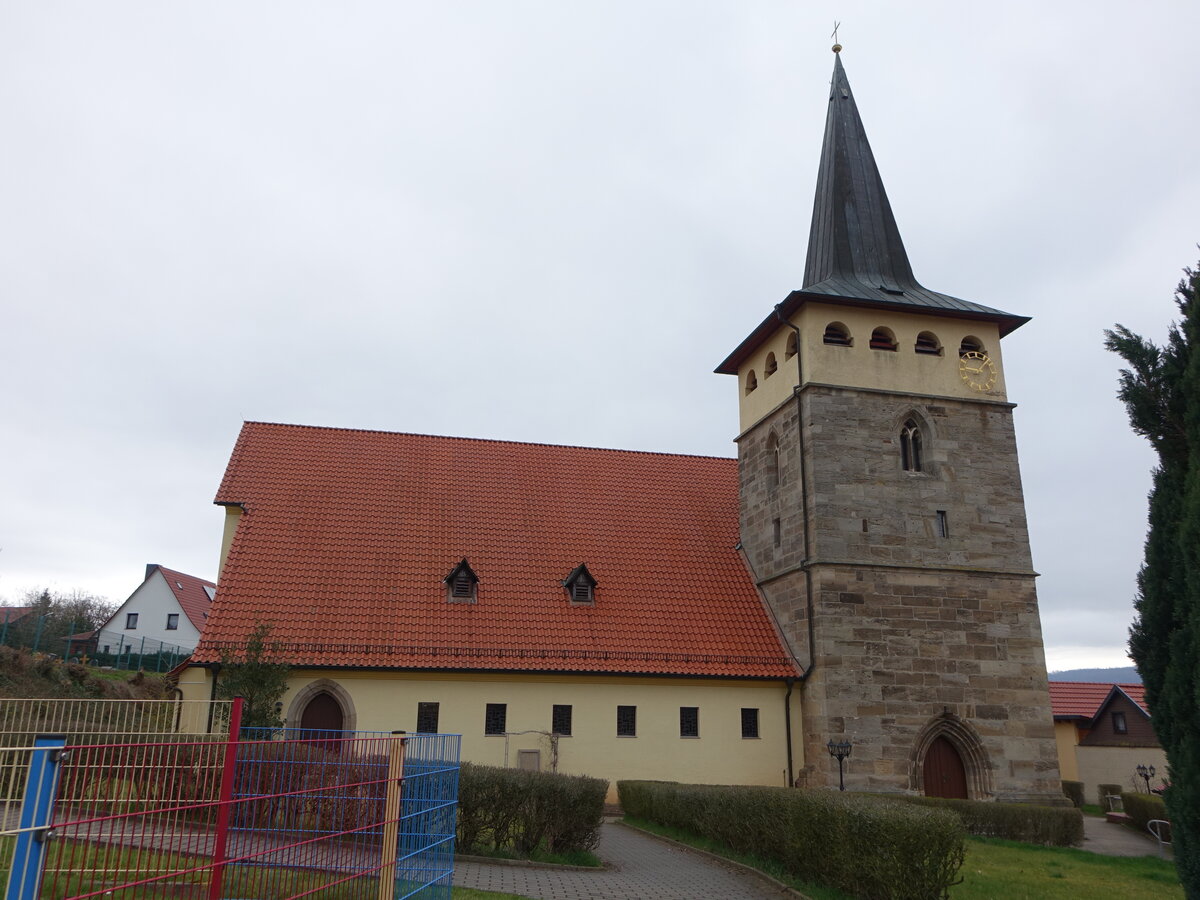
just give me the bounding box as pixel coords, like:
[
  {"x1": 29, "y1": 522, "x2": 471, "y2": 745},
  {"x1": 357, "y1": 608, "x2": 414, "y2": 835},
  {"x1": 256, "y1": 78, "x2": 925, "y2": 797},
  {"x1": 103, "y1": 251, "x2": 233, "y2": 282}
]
[{"x1": 716, "y1": 47, "x2": 1062, "y2": 802}]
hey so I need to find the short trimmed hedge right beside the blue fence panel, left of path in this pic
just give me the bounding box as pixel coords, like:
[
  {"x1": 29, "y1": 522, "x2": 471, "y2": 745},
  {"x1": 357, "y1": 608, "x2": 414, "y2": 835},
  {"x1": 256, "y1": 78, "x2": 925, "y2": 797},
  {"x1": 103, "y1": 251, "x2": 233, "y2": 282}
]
[{"x1": 457, "y1": 762, "x2": 608, "y2": 857}]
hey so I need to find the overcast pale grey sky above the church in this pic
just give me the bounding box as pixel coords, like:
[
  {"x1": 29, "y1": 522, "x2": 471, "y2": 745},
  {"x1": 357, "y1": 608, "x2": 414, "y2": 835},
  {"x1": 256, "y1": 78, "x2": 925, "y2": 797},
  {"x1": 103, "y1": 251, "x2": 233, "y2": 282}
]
[{"x1": 0, "y1": 0, "x2": 1200, "y2": 668}]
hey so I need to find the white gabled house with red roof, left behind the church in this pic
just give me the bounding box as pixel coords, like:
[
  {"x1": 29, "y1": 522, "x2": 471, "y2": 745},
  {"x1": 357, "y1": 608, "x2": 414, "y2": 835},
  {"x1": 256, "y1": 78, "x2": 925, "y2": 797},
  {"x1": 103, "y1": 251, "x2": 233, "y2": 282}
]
[{"x1": 94, "y1": 563, "x2": 216, "y2": 658}]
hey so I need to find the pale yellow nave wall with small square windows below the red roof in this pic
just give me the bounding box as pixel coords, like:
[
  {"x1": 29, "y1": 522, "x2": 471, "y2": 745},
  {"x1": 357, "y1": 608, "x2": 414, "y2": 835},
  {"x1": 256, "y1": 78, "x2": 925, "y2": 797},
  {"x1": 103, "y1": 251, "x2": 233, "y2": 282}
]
[{"x1": 179, "y1": 668, "x2": 804, "y2": 800}]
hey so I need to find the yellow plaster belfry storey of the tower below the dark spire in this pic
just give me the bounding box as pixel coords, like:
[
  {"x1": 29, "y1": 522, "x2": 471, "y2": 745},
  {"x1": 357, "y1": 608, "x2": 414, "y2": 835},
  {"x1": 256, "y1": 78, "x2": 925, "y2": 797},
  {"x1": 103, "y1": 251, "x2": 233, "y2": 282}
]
[{"x1": 738, "y1": 304, "x2": 1007, "y2": 431}]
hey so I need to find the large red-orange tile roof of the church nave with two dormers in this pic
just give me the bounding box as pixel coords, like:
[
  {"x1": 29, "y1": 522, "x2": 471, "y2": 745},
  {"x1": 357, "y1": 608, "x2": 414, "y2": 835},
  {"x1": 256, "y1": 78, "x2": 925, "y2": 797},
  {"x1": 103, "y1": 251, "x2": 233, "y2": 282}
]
[{"x1": 194, "y1": 422, "x2": 797, "y2": 678}]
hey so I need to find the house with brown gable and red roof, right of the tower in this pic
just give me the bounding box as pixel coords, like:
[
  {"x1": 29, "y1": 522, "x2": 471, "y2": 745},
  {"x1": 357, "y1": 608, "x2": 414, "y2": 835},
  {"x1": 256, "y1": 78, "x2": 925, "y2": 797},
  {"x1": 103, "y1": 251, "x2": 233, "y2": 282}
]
[{"x1": 1050, "y1": 682, "x2": 1166, "y2": 805}]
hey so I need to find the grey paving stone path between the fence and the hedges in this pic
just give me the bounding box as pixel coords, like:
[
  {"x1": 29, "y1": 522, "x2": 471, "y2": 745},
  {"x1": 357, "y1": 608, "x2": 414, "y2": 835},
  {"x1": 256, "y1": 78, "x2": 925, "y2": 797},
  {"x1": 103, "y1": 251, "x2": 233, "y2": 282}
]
[{"x1": 454, "y1": 823, "x2": 794, "y2": 900}]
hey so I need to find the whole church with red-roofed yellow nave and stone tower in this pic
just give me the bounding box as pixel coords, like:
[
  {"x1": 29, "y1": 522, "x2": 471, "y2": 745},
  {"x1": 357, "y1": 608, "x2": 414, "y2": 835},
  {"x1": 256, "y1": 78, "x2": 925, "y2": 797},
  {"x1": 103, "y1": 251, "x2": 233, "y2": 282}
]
[{"x1": 180, "y1": 47, "x2": 1062, "y2": 802}]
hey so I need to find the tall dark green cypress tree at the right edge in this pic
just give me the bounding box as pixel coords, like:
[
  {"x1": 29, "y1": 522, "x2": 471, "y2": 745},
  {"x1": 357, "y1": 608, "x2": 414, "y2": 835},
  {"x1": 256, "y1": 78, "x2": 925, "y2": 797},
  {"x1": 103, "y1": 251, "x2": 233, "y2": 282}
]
[{"x1": 1105, "y1": 260, "x2": 1200, "y2": 900}]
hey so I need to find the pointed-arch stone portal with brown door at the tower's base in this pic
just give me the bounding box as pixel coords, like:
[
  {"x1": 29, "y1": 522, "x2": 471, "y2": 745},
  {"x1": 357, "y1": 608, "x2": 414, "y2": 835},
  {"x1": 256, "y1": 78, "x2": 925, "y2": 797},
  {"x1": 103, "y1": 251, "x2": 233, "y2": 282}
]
[{"x1": 908, "y1": 709, "x2": 995, "y2": 800}]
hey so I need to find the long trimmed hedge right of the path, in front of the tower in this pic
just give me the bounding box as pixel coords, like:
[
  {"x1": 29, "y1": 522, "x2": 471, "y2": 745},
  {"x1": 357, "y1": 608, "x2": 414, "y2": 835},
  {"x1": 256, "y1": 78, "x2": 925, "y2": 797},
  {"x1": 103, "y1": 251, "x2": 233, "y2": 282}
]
[{"x1": 617, "y1": 781, "x2": 964, "y2": 900}]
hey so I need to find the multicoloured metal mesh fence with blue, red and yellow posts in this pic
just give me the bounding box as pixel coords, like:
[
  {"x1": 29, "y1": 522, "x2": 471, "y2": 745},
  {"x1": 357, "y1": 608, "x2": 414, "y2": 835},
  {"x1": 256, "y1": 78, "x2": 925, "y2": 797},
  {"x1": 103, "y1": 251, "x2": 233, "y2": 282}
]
[{"x1": 0, "y1": 701, "x2": 458, "y2": 900}]
